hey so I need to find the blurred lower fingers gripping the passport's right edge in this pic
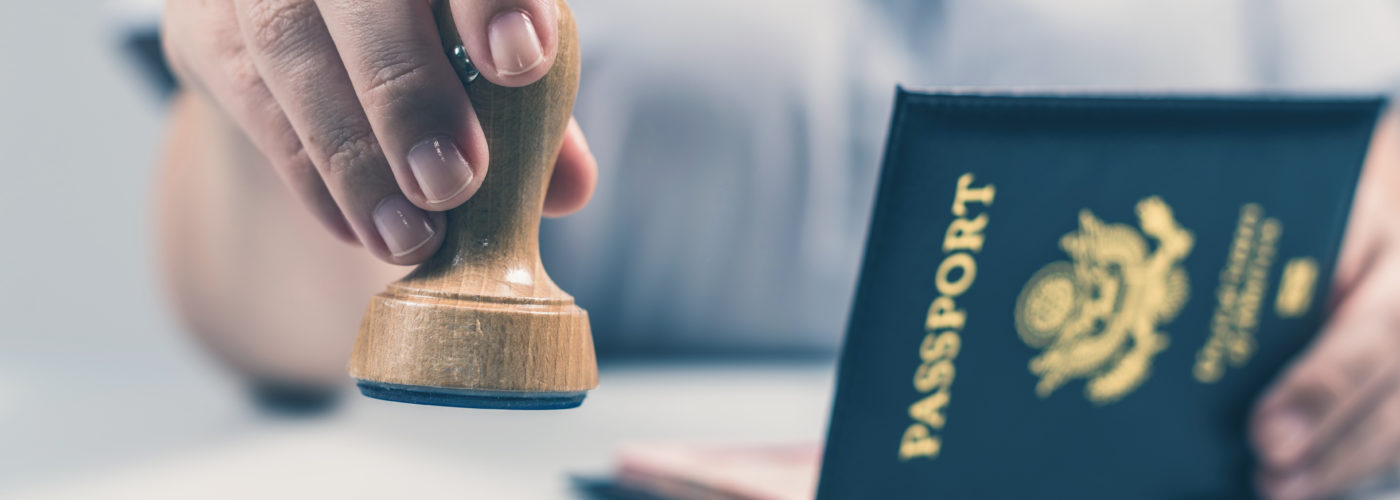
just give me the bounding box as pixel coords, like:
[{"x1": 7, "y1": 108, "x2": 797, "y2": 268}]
[{"x1": 1250, "y1": 258, "x2": 1400, "y2": 497}]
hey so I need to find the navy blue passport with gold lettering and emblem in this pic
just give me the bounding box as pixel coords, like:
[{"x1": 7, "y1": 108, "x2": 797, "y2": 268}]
[{"x1": 818, "y1": 90, "x2": 1383, "y2": 499}]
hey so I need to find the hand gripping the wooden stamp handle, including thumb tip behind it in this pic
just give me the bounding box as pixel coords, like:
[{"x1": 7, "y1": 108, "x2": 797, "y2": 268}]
[{"x1": 162, "y1": 0, "x2": 596, "y2": 265}]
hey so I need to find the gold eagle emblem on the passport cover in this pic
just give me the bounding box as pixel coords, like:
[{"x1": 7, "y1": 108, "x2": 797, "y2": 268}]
[{"x1": 1016, "y1": 196, "x2": 1194, "y2": 405}]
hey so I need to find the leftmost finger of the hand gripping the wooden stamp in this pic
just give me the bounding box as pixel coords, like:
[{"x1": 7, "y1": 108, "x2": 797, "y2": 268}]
[{"x1": 161, "y1": 1, "x2": 357, "y2": 242}]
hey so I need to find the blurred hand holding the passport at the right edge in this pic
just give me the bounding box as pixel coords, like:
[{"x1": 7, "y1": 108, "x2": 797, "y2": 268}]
[{"x1": 1250, "y1": 111, "x2": 1400, "y2": 499}]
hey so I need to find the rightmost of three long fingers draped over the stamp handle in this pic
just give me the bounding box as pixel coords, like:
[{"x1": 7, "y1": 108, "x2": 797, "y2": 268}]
[{"x1": 319, "y1": 0, "x2": 487, "y2": 211}]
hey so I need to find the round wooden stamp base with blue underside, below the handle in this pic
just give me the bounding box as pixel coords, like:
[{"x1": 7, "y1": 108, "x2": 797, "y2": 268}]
[{"x1": 350, "y1": 284, "x2": 598, "y2": 409}]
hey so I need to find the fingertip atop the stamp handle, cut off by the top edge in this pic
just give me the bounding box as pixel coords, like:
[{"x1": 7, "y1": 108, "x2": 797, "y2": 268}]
[{"x1": 442, "y1": 0, "x2": 559, "y2": 87}]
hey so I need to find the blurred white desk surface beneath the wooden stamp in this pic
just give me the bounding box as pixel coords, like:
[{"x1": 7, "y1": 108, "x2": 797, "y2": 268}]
[{"x1": 10, "y1": 354, "x2": 1400, "y2": 499}]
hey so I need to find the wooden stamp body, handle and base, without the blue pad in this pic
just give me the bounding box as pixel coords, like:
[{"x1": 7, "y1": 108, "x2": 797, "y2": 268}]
[{"x1": 350, "y1": 0, "x2": 598, "y2": 392}]
